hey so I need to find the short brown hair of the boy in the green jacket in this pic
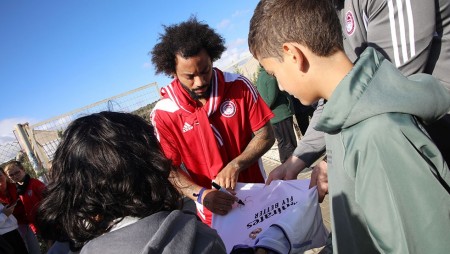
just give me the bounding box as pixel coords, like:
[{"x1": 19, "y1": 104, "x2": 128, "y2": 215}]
[{"x1": 248, "y1": 0, "x2": 343, "y2": 60}]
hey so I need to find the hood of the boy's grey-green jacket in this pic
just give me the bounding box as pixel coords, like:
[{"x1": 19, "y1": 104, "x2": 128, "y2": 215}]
[{"x1": 316, "y1": 47, "x2": 450, "y2": 133}]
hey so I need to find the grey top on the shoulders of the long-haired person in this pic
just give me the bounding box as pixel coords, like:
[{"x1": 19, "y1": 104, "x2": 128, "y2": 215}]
[{"x1": 81, "y1": 210, "x2": 225, "y2": 254}]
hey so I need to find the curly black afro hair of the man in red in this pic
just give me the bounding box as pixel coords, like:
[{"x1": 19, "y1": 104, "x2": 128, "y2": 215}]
[{"x1": 149, "y1": 16, "x2": 226, "y2": 76}]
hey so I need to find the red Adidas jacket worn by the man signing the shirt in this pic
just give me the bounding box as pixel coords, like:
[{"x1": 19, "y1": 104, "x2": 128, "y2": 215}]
[{"x1": 152, "y1": 69, "x2": 273, "y2": 224}]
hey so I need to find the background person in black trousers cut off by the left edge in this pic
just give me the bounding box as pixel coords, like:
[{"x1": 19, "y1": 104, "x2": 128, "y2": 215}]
[{"x1": 0, "y1": 168, "x2": 28, "y2": 254}]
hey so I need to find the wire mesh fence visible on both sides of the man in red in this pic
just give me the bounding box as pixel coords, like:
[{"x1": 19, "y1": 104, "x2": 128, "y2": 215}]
[{"x1": 0, "y1": 54, "x2": 259, "y2": 169}]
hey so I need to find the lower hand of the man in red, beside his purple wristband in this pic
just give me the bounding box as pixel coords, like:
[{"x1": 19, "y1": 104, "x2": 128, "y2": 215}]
[{"x1": 202, "y1": 189, "x2": 236, "y2": 215}]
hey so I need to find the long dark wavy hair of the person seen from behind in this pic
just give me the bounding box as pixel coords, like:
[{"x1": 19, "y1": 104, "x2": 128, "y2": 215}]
[{"x1": 37, "y1": 111, "x2": 182, "y2": 247}]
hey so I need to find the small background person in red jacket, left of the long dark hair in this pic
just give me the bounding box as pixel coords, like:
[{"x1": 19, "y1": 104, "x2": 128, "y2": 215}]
[{"x1": 5, "y1": 160, "x2": 45, "y2": 254}]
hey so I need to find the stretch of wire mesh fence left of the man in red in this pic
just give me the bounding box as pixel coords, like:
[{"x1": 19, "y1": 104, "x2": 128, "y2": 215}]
[{"x1": 0, "y1": 83, "x2": 160, "y2": 173}]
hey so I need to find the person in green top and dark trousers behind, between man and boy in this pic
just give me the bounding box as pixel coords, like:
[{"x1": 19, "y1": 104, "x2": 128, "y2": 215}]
[{"x1": 256, "y1": 67, "x2": 297, "y2": 163}]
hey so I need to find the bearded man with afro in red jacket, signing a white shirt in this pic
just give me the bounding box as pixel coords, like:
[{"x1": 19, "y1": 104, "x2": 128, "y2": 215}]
[{"x1": 151, "y1": 17, "x2": 275, "y2": 225}]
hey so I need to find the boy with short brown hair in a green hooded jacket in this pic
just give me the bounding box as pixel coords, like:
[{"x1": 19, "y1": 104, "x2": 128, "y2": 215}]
[{"x1": 248, "y1": 0, "x2": 450, "y2": 253}]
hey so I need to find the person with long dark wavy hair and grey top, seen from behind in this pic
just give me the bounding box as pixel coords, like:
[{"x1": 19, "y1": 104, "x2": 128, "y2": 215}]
[{"x1": 38, "y1": 111, "x2": 225, "y2": 253}]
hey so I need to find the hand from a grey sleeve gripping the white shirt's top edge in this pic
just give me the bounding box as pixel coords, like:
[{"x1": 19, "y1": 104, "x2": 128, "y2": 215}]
[{"x1": 266, "y1": 156, "x2": 306, "y2": 185}]
